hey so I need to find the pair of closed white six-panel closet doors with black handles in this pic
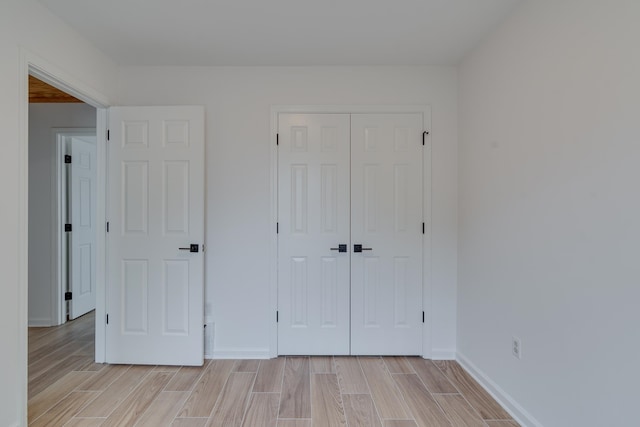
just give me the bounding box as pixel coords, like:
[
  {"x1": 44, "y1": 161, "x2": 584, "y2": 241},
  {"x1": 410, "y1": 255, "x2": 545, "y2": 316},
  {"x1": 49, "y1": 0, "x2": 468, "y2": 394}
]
[{"x1": 278, "y1": 114, "x2": 424, "y2": 355}]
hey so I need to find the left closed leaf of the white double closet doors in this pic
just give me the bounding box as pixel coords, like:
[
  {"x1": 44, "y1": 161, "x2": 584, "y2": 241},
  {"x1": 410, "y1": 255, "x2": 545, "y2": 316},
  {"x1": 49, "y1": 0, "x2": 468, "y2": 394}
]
[{"x1": 278, "y1": 114, "x2": 350, "y2": 355}]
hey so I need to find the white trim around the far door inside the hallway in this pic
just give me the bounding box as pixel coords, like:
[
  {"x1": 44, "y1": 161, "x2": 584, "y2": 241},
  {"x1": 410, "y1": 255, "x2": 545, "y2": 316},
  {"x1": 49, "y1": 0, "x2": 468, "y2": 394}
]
[{"x1": 51, "y1": 128, "x2": 97, "y2": 325}]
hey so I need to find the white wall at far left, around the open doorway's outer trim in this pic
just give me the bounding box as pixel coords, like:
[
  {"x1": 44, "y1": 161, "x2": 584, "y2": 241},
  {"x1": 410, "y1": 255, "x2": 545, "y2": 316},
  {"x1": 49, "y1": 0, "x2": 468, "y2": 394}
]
[{"x1": 0, "y1": 0, "x2": 116, "y2": 426}]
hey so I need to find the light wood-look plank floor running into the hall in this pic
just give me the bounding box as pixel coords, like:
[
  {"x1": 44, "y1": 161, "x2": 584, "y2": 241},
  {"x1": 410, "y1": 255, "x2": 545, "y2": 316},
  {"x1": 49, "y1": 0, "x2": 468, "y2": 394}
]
[{"x1": 28, "y1": 314, "x2": 518, "y2": 427}]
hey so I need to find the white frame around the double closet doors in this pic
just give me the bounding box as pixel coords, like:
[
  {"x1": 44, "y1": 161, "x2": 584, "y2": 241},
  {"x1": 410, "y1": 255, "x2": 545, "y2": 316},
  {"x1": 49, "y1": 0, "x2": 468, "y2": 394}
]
[{"x1": 269, "y1": 105, "x2": 432, "y2": 359}]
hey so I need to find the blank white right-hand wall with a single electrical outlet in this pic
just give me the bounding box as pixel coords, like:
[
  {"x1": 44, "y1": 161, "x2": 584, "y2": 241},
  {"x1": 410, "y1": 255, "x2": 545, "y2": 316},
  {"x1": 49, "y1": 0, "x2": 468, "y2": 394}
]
[{"x1": 458, "y1": 0, "x2": 640, "y2": 427}]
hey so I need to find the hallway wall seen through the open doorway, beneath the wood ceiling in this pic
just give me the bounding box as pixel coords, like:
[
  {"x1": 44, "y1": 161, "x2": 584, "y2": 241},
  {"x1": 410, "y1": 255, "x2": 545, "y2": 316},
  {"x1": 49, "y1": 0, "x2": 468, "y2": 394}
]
[{"x1": 29, "y1": 104, "x2": 96, "y2": 326}]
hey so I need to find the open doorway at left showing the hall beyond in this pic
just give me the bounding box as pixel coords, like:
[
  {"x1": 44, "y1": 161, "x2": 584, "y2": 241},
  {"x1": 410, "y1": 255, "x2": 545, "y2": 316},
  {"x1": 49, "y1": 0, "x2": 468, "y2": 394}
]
[{"x1": 28, "y1": 76, "x2": 97, "y2": 398}]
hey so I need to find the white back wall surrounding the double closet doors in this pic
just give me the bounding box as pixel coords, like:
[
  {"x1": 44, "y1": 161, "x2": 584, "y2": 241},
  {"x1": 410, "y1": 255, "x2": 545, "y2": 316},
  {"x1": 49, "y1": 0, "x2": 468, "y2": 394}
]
[{"x1": 119, "y1": 67, "x2": 457, "y2": 356}]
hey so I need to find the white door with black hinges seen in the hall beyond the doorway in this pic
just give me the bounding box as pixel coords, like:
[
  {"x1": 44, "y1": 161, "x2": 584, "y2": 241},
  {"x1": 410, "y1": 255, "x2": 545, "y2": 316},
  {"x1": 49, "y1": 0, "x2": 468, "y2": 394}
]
[{"x1": 69, "y1": 137, "x2": 97, "y2": 319}]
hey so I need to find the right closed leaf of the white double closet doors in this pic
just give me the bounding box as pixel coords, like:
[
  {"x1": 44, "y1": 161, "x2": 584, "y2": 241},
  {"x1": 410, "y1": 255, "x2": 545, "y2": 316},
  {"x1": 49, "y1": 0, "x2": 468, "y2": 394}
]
[{"x1": 351, "y1": 114, "x2": 423, "y2": 355}]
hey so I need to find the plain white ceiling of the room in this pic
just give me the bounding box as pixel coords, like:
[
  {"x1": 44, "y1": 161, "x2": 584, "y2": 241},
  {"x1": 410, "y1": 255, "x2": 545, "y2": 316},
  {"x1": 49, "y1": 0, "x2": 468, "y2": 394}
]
[{"x1": 39, "y1": 0, "x2": 524, "y2": 66}]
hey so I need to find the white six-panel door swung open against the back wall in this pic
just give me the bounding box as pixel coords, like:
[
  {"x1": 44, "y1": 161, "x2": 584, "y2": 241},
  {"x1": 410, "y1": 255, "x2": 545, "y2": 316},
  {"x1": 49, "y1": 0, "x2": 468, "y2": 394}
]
[{"x1": 106, "y1": 107, "x2": 204, "y2": 365}]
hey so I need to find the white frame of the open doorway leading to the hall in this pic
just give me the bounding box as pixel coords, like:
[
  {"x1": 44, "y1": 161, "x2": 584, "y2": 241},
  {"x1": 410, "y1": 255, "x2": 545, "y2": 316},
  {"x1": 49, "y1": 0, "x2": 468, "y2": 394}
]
[{"x1": 16, "y1": 47, "x2": 110, "y2": 426}]
